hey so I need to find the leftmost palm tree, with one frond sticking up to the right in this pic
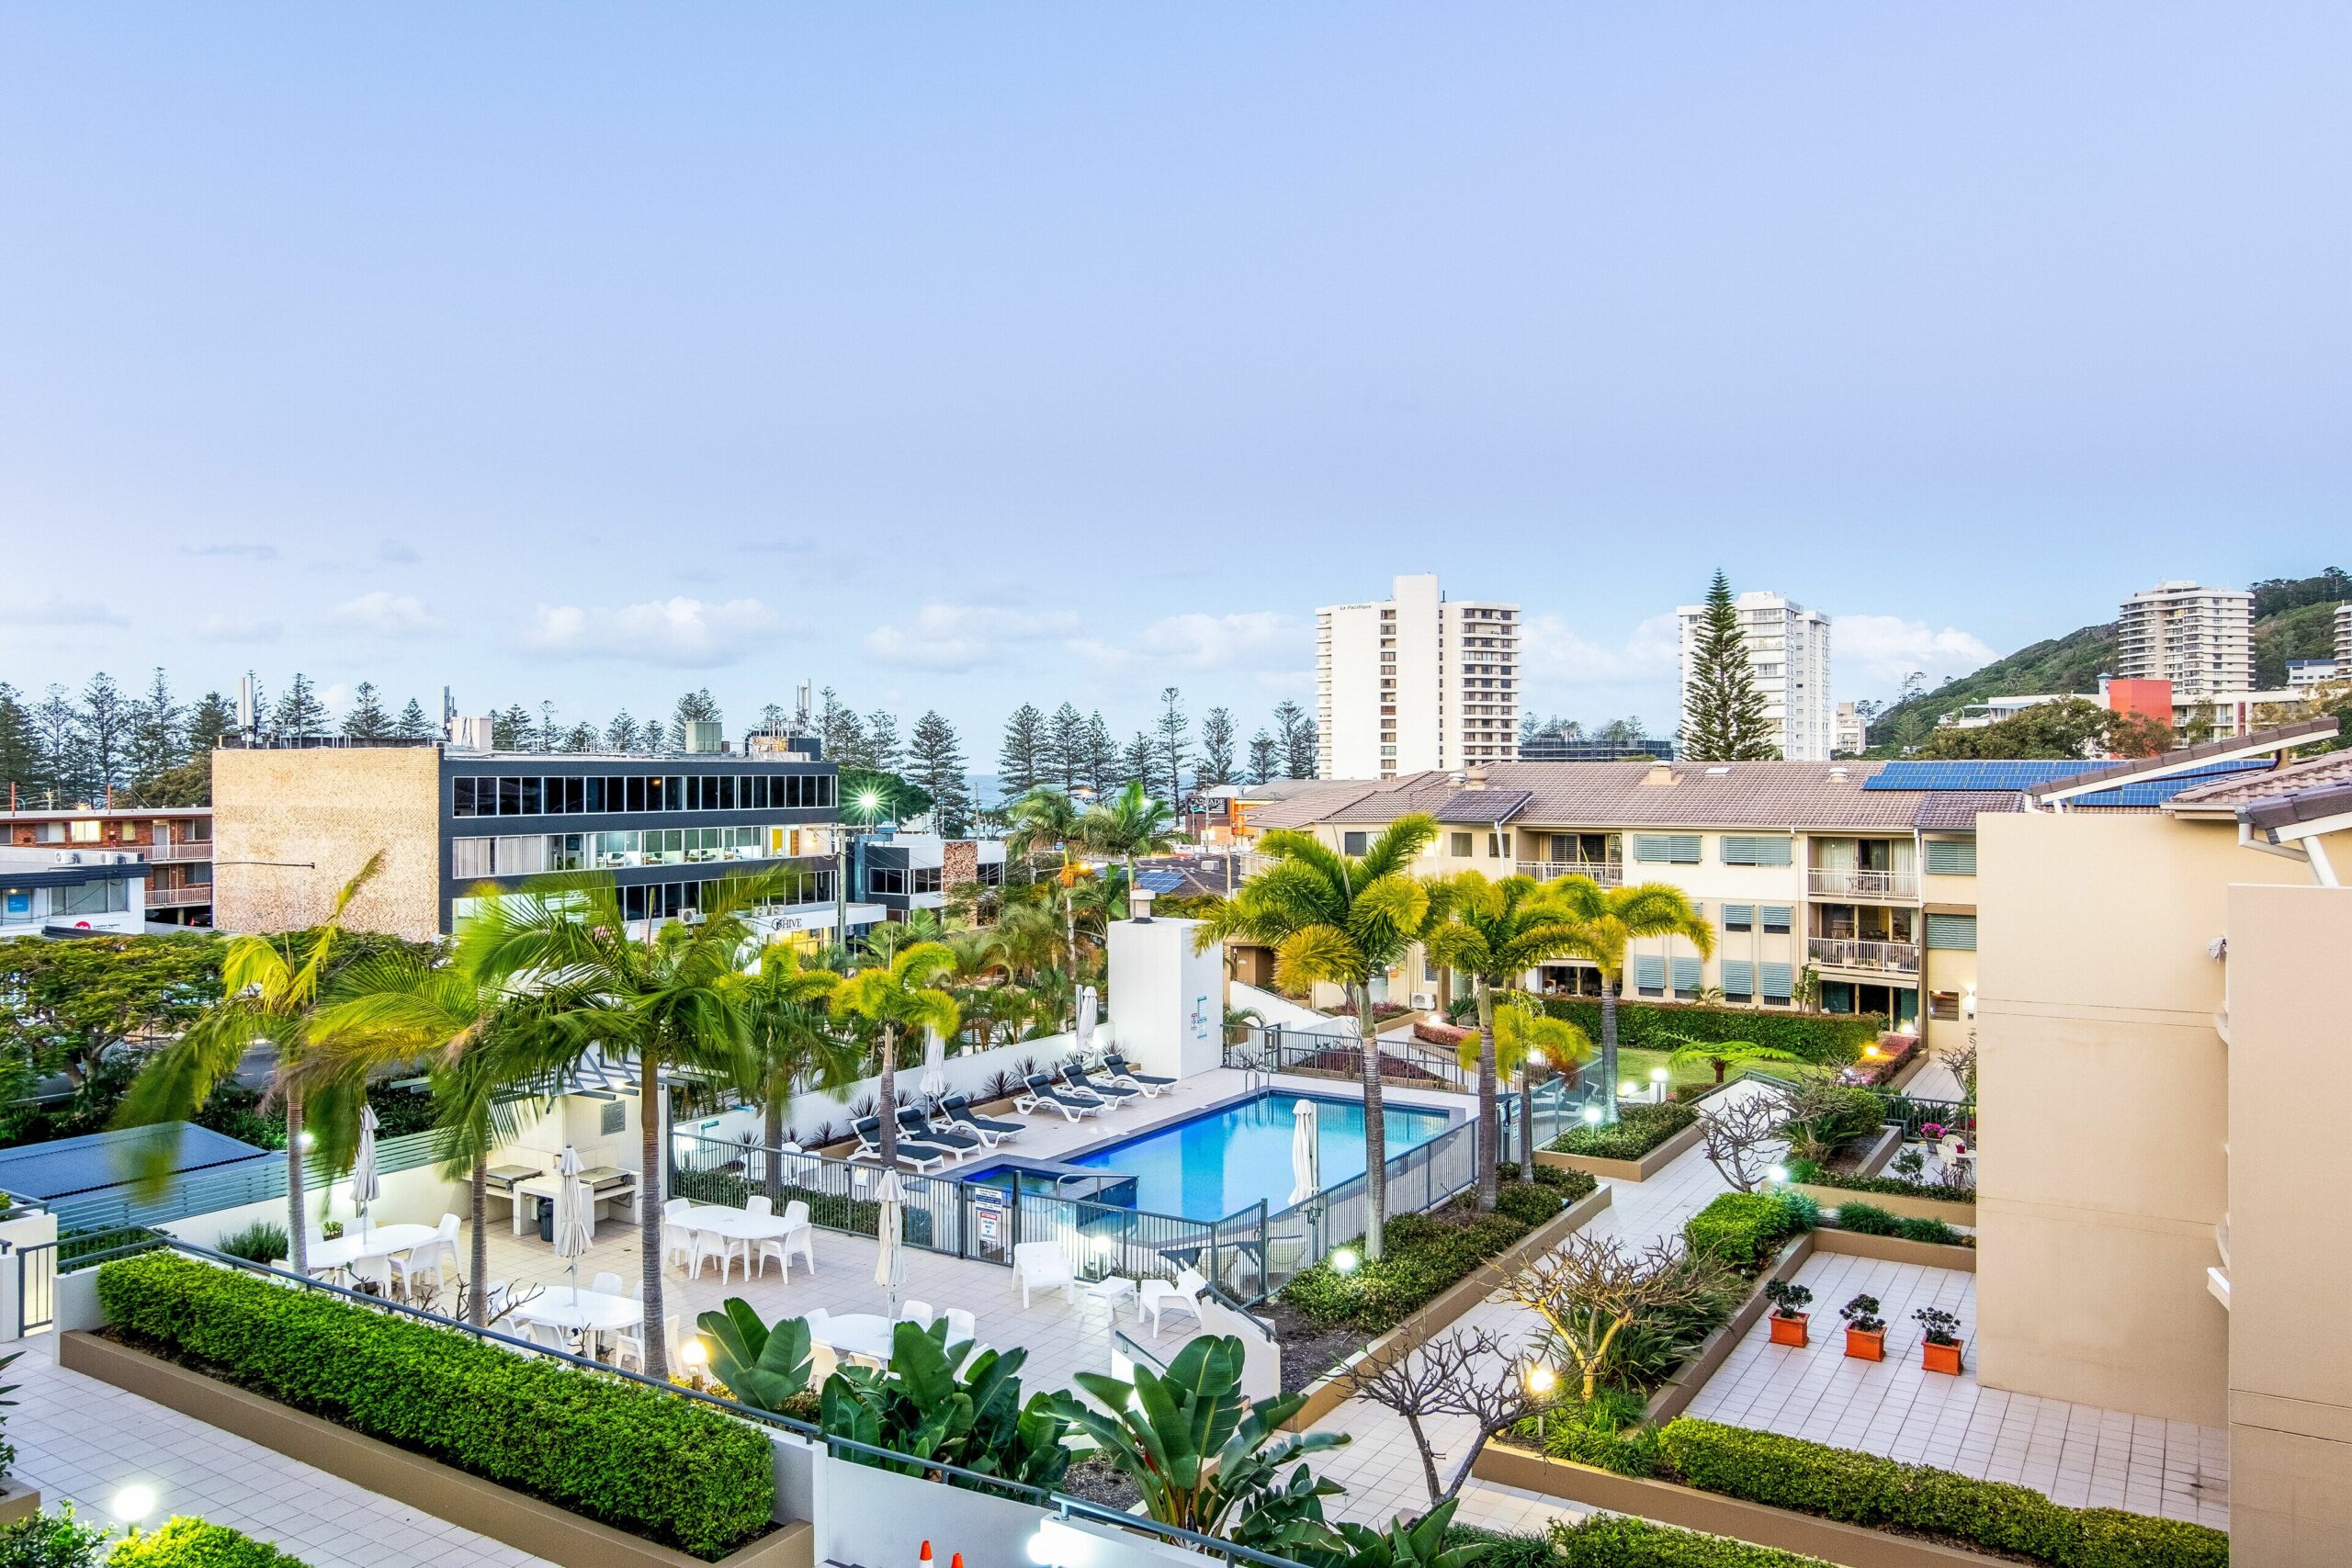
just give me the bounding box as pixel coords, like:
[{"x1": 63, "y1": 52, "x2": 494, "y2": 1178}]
[{"x1": 115, "y1": 849, "x2": 383, "y2": 1274}]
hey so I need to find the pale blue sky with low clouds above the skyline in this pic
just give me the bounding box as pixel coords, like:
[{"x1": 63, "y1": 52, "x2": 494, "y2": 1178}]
[{"x1": 0, "y1": 3, "x2": 2352, "y2": 747}]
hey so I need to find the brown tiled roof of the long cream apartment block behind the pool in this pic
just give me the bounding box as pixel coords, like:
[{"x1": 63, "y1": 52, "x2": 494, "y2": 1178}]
[{"x1": 1251, "y1": 761, "x2": 2018, "y2": 832}]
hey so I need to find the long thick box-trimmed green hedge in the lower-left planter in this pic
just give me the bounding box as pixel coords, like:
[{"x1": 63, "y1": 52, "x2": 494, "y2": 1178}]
[{"x1": 99, "y1": 1253, "x2": 776, "y2": 1559}]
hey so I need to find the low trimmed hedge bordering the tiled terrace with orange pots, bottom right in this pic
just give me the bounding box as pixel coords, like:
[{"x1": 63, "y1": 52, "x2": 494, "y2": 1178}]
[{"x1": 1658, "y1": 1416, "x2": 2230, "y2": 1568}]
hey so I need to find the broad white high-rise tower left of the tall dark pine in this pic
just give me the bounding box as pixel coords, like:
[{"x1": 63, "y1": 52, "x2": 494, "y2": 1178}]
[{"x1": 1315, "y1": 576, "x2": 1520, "y2": 778}]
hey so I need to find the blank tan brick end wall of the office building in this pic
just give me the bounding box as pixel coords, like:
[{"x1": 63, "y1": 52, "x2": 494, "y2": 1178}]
[{"x1": 211, "y1": 745, "x2": 442, "y2": 941}]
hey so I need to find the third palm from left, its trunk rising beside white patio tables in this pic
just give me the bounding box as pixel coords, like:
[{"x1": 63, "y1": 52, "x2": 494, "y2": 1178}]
[{"x1": 466, "y1": 867, "x2": 786, "y2": 1382}]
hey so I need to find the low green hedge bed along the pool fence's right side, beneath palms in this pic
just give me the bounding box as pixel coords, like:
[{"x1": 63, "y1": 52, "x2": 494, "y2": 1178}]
[{"x1": 1282, "y1": 1166, "x2": 1600, "y2": 1336}]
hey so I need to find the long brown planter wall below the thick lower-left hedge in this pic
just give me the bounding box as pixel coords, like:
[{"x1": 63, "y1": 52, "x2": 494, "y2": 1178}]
[{"x1": 56, "y1": 1333, "x2": 816, "y2": 1568}]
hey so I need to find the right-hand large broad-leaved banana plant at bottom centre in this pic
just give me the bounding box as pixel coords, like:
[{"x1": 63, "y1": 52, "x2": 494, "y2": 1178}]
[{"x1": 1058, "y1": 1336, "x2": 1348, "y2": 1556}]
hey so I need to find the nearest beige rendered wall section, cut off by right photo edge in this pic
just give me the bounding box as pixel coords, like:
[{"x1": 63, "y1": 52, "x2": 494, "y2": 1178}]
[{"x1": 2227, "y1": 884, "x2": 2352, "y2": 1568}]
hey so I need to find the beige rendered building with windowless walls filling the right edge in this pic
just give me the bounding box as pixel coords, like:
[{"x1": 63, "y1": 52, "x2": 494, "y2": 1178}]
[{"x1": 1975, "y1": 719, "x2": 2352, "y2": 1568}]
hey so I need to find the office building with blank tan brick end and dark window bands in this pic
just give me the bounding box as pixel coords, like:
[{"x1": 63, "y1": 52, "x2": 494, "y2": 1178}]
[{"x1": 211, "y1": 740, "x2": 882, "y2": 941}]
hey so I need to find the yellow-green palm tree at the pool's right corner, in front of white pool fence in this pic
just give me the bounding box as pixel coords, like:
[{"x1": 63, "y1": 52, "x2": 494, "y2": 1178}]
[{"x1": 1194, "y1": 813, "x2": 1449, "y2": 1260}]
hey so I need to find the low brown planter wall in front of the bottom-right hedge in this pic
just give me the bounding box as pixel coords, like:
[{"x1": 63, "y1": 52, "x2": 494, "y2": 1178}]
[{"x1": 1470, "y1": 1441, "x2": 2016, "y2": 1568}]
